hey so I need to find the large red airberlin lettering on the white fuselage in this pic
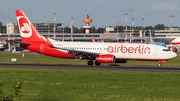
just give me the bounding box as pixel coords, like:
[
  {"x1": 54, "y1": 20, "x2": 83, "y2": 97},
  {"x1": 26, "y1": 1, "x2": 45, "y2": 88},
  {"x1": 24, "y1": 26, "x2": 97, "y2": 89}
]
[{"x1": 107, "y1": 45, "x2": 150, "y2": 54}]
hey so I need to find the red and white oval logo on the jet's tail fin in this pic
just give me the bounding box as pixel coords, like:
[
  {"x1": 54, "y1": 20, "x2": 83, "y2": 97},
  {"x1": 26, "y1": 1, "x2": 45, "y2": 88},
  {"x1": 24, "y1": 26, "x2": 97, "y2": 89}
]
[{"x1": 19, "y1": 17, "x2": 32, "y2": 38}]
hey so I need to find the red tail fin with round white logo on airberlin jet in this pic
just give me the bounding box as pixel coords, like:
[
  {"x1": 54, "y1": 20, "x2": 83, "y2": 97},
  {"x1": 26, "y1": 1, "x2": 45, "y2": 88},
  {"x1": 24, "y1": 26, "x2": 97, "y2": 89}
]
[{"x1": 16, "y1": 10, "x2": 44, "y2": 43}]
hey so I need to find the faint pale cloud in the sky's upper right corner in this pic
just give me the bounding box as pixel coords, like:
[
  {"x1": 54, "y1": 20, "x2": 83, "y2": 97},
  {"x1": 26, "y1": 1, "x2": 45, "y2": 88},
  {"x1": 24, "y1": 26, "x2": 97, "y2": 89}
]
[{"x1": 148, "y1": 1, "x2": 180, "y2": 10}]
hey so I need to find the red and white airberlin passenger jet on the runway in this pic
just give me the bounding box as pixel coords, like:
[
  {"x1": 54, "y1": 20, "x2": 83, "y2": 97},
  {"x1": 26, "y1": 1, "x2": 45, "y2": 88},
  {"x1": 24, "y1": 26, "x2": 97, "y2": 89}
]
[{"x1": 15, "y1": 10, "x2": 177, "y2": 66}]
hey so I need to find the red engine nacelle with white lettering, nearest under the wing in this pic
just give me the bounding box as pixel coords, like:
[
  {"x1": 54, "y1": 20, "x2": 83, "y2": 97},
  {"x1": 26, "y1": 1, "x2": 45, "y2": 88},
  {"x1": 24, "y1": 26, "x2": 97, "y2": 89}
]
[{"x1": 97, "y1": 55, "x2": 116, "y2": 63}]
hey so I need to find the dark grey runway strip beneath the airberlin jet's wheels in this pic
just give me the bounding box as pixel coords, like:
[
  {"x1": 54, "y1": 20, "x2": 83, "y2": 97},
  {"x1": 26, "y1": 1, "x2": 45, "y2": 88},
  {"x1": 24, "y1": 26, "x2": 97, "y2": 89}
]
[{"x1": 0, "y1": 63, "x2": 180, "y2": 72}]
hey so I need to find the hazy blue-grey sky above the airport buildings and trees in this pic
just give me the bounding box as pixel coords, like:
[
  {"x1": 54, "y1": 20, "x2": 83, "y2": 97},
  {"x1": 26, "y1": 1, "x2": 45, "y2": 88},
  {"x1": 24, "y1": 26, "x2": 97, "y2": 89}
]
[{"x1": 0, "y1": 0, "x2": 180, "y2": 28}]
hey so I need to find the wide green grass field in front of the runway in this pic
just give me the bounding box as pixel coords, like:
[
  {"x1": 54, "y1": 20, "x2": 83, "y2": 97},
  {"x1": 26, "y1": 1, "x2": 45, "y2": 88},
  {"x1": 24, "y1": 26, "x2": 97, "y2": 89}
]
[{"x1": 0, "y1": 68, "x2": 180, "y2": 101}]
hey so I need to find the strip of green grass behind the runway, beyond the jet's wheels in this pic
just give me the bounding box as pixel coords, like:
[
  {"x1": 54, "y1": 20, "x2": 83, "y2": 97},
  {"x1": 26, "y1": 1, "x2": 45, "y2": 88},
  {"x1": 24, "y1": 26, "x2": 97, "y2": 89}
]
[{"x1": 0, "y1": 54, "x2": 180, "y2": 66}]
